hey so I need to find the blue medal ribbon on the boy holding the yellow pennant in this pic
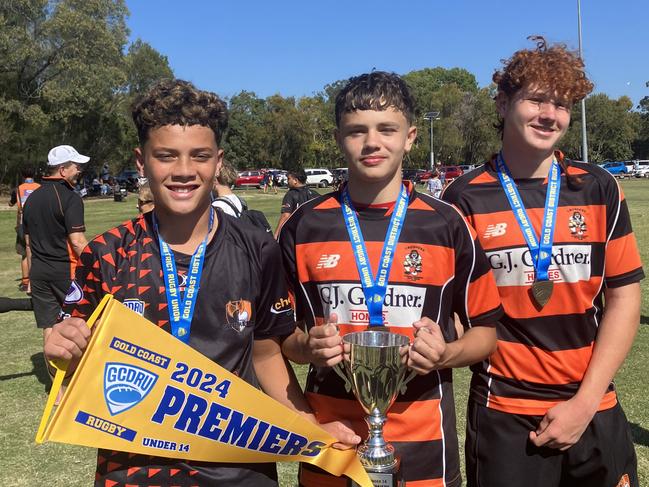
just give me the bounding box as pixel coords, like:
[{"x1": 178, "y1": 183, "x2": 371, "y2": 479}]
[{"x1": 153, "y1": 207, "x2": 214, "y2": 343}]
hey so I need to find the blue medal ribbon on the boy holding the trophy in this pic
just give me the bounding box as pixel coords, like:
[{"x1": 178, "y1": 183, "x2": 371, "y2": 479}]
[{"x1": 340, "y1": 185, "x2": 408, "y2": 326}]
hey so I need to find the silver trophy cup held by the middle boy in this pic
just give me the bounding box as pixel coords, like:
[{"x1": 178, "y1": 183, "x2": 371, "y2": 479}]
[{"x1": 334, "y1": 331, "x2": 416, "y2": 487}]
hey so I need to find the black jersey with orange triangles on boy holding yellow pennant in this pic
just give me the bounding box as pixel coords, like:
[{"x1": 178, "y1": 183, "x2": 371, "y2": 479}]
[{"x1": 63, "y1": 212, "x2": 295, "y2": 487}]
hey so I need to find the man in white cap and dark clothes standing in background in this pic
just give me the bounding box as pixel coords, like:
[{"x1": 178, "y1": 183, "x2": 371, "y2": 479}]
[{"x1": 23, "y1": 145, "x2": 90, "y2": 366}]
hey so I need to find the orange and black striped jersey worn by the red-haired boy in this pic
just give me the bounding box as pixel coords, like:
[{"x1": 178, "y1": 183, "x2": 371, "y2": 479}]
[{"x1": 443, "y1": 158, "x2": 644, "y2": 415}]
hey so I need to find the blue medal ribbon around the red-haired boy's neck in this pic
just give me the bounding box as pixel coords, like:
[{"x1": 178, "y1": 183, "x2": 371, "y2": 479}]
[{"x1": 496, "y1": 153, "x2": 561, "y2": 281}]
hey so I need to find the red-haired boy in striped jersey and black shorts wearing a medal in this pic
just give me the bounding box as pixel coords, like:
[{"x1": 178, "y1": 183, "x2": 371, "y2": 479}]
[{"x1": 443, "y1": 38, "x2": 644, "y2": 487}]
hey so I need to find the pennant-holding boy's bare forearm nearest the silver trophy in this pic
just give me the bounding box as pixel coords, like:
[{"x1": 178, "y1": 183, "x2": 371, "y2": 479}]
[{"x1": 253, "y1": 339, "x2": 317, "y2": 422}]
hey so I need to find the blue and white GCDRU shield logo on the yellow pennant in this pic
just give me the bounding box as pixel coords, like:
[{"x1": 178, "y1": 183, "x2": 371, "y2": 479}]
[{"x1": 104, "y1": 362, "x2": 158, "y2": 416}]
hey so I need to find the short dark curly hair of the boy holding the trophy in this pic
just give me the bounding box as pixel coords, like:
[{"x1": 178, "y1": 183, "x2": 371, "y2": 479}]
[{"x1": 336, "y1": 71, "x2": 415, "y2": 127}]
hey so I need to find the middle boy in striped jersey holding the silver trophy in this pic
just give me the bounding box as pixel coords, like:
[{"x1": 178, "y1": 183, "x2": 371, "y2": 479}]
[{"x1": 279, "y1": 72, "x2": 501, "y2": 487}]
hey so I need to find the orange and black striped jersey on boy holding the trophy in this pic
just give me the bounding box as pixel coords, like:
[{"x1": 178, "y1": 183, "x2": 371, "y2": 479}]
[{"x1": 280, "y1": 186, "x2": 502, "y2": 486}]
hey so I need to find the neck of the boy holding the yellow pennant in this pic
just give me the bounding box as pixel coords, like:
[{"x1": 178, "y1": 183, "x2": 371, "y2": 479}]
[{"x1": 154, "y1": 206, "x2": 217, "y2": 254}]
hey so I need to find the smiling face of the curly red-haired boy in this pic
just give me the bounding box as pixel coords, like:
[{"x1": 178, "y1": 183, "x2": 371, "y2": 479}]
[{"x1": 496, "y1": 85, "x2": 571, "y2": 151}]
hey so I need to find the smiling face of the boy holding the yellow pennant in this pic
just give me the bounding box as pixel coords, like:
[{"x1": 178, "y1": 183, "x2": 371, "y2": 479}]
[{"x1": 135, "y1": 125, "x2": 223, "y2": 215}]
